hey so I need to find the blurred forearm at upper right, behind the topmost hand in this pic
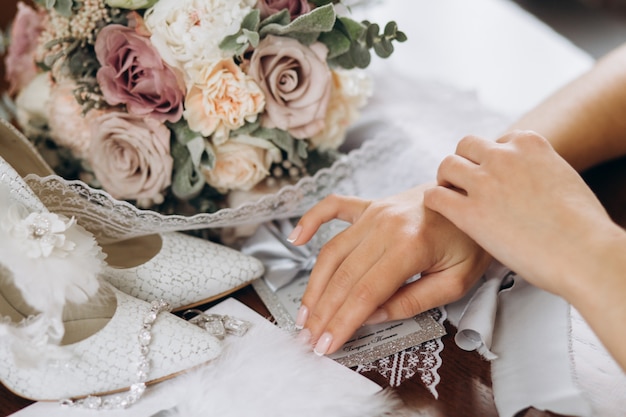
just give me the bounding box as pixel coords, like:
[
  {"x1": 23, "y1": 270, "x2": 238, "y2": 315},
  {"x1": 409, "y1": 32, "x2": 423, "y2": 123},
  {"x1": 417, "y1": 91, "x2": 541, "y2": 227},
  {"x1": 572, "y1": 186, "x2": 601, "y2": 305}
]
[{"x1": 511, "y1": 45, "x2": 626, "y2": 172}]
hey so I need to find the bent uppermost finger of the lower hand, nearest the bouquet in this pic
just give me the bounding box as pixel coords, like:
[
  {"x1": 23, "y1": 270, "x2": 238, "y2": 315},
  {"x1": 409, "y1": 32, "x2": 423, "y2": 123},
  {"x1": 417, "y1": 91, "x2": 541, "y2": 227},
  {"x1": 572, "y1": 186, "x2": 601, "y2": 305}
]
[{"x1": 288, "y1": 194, "x2": 370, "y2": 245}]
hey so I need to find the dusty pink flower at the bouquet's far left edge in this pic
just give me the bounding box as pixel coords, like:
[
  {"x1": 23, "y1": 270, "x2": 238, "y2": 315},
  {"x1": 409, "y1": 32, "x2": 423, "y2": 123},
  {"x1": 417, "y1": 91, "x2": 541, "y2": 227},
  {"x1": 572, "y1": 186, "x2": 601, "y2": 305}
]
[{"x1": 4, "y1": 2, "x2": 45, "y2": 94}]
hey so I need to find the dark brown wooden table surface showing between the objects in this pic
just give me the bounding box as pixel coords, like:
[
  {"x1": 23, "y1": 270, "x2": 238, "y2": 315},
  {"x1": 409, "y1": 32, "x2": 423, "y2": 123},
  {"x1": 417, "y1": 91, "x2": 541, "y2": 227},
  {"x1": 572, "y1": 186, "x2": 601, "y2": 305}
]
[{"x1": 0, "y1": 0, "x2": 626, "y2": 417}]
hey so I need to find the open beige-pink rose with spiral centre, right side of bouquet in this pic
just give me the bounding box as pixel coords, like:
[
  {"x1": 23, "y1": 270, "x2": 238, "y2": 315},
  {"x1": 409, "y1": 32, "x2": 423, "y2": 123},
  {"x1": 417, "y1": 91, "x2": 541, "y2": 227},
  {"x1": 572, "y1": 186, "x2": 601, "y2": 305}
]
[{"x1": 250, "y1": 35, "x2": 332, "y2": 139}]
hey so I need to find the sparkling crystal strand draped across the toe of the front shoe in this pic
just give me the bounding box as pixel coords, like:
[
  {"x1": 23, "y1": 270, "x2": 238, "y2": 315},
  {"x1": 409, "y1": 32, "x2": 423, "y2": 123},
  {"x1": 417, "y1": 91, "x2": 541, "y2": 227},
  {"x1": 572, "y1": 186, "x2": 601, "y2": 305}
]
[{"x1": 60, "y1": 300, "x2": 171, "y2": 410}]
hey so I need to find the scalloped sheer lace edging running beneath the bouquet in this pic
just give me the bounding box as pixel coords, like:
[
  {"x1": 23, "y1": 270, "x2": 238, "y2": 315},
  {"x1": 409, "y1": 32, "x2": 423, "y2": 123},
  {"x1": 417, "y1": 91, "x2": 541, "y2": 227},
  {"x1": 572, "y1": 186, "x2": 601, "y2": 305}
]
[{"x1": 25, "y1": 131, "x2": 397, "y2": 244}]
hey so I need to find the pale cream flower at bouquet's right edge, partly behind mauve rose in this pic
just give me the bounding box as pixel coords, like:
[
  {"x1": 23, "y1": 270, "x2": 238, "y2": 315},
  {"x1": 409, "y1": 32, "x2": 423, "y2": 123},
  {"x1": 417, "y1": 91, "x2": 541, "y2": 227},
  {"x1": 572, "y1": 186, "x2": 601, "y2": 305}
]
[{"x1": 310, "y1": 69, "x2": 372, "y2": 150}]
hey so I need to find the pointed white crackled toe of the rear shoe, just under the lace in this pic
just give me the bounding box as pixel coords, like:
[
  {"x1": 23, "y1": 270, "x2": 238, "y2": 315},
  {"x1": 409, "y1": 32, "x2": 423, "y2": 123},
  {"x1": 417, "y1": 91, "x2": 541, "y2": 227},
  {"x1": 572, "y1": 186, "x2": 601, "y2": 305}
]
[{"x1": 103, "y1": 232, "x2": 264, "y2": 311}]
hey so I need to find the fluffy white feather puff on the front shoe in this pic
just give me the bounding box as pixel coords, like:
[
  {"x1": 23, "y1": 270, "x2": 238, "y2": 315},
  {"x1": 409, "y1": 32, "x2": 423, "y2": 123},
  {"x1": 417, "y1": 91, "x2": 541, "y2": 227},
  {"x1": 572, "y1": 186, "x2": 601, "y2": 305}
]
[{"x1": 0, "y1": 184, "x2": 104, "y2": 365}]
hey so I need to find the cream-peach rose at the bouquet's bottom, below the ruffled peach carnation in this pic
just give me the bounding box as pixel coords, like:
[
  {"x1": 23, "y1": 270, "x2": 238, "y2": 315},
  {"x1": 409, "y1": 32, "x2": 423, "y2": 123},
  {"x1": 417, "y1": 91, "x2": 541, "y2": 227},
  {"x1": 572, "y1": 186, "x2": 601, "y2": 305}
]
[{"x1": 202, "y1": 135, "x2": 280, "y2": 193}]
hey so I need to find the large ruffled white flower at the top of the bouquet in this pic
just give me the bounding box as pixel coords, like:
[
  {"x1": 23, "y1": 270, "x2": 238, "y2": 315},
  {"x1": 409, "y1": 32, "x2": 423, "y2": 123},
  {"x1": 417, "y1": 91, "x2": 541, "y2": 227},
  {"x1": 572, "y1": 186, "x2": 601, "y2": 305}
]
[{"x1": 145, "y1": 0, "x2": 256, "y2": 77}]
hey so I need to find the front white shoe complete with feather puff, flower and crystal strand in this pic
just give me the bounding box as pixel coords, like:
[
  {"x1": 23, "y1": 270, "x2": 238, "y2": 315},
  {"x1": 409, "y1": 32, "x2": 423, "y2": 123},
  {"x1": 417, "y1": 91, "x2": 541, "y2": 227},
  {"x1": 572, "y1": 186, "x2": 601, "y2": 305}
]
[{"x1": 0, "y1": 158, "x2": 221, "y2": 402}]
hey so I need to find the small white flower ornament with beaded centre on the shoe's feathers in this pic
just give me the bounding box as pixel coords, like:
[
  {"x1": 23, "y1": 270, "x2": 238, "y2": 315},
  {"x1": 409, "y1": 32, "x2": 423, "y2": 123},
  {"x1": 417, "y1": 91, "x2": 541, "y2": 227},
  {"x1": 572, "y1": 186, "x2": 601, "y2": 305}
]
[{"x1": 11, "y1": 213, "x2": 76, "y2": 258}]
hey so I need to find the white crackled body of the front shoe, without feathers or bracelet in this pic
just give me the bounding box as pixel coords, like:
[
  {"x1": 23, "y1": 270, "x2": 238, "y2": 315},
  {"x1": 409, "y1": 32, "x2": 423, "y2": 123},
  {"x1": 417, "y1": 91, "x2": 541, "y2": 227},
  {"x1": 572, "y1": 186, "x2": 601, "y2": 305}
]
[{"x1": 0, "y1": 284, "x2": 221, "y2": 401}]
